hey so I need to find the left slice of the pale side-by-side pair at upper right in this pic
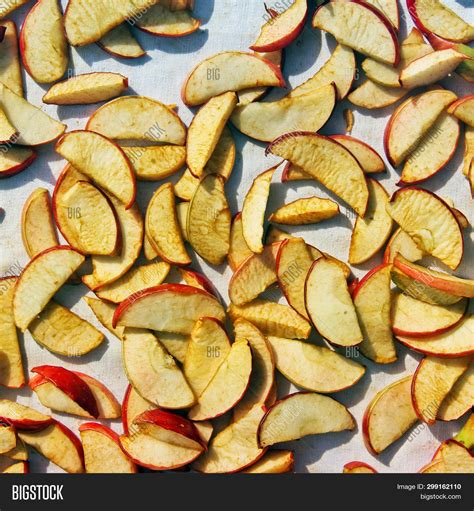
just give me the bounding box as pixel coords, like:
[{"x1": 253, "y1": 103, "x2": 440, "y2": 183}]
[{"x1": 384, "y1": 89, "x2": 456, "y2": 167}]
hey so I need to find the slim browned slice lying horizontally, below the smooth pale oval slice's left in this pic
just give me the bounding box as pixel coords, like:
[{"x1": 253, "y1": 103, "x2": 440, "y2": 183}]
[{"x1": 227, "y1": 300, "x2": 311, "y2": 339}]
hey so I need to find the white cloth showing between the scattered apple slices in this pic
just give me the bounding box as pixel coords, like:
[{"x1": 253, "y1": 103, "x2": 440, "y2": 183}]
[{"x1": 0, "y1": 0, "x2": 474, "y2": 472}]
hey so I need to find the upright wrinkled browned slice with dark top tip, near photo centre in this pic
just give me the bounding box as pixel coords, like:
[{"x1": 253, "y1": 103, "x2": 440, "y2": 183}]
[{"x1": 186, "y1": 174, "x2": 231, "y2": 264}]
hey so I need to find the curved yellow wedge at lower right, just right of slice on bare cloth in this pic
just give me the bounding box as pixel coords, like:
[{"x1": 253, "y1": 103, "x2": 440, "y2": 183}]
[{"x1": 412, "y1": 356, "x2": 471, "y2": 424}]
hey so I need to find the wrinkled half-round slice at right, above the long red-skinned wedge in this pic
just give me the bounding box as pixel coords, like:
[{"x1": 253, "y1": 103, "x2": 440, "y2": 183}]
[{"x1": 387, "y1": 187, "x2": 464, "y2": 270}]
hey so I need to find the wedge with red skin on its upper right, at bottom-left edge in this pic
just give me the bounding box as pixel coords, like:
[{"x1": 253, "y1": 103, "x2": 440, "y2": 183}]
[{"x1": 18, "y1": 421, "x2": 84, "y2": 474}]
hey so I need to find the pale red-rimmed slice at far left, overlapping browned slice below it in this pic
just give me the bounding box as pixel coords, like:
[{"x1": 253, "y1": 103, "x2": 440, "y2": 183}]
[{"x1": 13, "y1": 246, "x2": 84, "y2": 332}]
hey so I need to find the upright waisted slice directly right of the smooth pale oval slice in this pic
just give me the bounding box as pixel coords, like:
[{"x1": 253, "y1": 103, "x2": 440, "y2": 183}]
[{"x1": 352, "y1": 264, "x2": 397, "y2": 364}]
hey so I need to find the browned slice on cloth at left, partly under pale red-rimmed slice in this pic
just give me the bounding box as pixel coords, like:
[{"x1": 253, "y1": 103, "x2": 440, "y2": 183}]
[{"x1": 28, "y1": 300, "x2": 105, "y2": 357}]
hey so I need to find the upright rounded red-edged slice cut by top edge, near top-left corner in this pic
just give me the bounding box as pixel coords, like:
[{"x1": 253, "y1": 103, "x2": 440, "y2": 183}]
[{"x1": 20, "y1": 0, "x2": 69, "y2": 83}]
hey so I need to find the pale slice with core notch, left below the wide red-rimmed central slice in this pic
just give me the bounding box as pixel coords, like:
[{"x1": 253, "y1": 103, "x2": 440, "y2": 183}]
[{"x1": 122, "y1": 328, "x2": 196, "y2": 409}]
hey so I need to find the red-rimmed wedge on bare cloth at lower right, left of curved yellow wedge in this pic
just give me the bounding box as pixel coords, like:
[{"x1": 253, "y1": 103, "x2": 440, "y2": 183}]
[{"x1": 362, "y1": 376, "x2": 418, "y2": 455}]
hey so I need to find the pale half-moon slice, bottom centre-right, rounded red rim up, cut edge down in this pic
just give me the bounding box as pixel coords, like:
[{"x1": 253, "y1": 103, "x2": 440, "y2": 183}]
[{"x1": 258, "y1": 392, "x2": 356, "y2": 447}]
